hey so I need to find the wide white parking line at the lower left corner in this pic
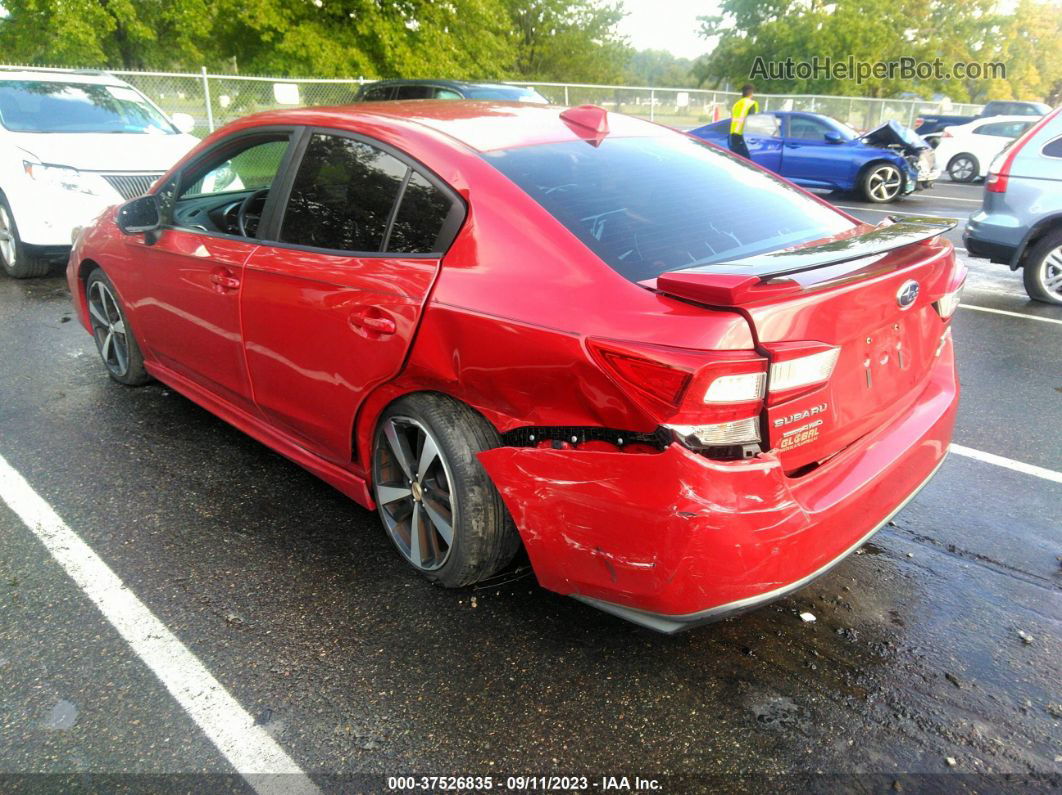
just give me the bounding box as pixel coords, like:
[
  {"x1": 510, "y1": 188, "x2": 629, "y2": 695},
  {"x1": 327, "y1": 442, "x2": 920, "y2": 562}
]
[{"x1": 0, "y1": 455, "x2": 319, "y2": 795}]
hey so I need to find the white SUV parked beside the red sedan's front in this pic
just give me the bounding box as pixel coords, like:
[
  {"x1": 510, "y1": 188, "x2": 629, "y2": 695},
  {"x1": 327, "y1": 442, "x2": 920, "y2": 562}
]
[{"x1": 0, "y1": 70, "x2": 199, "y2": 278}]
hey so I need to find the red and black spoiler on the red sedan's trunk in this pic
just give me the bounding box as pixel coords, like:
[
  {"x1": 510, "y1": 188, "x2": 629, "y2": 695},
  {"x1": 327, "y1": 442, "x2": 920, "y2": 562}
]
[{"x1": 656, "y1": 215, "x2": 959, "y2": 306}]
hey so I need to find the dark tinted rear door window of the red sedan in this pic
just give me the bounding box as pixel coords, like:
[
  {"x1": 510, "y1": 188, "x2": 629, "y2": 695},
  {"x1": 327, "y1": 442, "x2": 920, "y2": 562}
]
[{"x1": 280, "y1": 134, "x2": 407, "y2": 252}]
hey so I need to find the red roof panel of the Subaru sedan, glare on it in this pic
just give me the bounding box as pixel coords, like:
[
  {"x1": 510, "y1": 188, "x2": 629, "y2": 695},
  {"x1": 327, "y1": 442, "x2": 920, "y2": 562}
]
[{"x1": 239, "y1": 100, "x2": 662, "y2": 152}]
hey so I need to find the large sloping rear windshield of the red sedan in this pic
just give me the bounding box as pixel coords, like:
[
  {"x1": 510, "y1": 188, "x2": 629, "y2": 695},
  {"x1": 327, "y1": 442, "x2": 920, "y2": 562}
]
[{"x1": 484, "y1": 135, "x2": 854, "y2": 281}]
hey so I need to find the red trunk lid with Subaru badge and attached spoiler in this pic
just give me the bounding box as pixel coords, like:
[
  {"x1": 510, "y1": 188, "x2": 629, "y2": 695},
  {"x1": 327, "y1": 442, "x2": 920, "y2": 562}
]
[{"x1": 654, "y1": 219, "x2": 957, "y2": 471}]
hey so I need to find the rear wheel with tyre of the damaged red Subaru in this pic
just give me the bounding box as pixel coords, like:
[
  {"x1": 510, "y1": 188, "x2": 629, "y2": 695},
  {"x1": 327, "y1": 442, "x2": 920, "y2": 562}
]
[{"x1": 373, "y1": 394, "x2": 519, "y2": 588}]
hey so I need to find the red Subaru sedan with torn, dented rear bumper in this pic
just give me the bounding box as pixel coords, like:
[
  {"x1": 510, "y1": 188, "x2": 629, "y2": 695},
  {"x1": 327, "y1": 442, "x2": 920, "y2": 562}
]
[{"x1": 68, "y1": 101, "x2": 964, "y2": 632}]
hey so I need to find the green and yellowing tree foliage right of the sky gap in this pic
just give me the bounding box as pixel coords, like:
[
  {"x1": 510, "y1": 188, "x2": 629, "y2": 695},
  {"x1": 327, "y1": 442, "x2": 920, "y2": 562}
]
[{"x1": 693, "y1": 0, "x2": 1062, "y2": 101}]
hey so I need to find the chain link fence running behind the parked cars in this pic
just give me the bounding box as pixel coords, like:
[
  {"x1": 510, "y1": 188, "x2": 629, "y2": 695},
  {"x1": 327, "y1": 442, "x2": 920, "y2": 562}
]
[{"x1": 0, "y1": 66, "x2": 982, "y2": 136}]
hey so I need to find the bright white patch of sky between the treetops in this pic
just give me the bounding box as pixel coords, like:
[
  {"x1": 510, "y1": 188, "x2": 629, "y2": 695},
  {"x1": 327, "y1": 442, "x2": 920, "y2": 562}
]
[{"x1": 619, "y1": 0, "x2": 719, "y2": 58}]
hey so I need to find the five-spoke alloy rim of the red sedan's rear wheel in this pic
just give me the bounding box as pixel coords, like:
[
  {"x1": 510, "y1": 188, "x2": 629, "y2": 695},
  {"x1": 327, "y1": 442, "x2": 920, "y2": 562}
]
[{"x1": 373, "y1": 416, "x2": 458, "y2": 571}]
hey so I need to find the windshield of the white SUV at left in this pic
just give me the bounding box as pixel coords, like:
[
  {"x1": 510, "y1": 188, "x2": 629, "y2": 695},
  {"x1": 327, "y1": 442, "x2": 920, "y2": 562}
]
[{"x1": 0, "y1": 81, "x2": 177, "y2": 135}]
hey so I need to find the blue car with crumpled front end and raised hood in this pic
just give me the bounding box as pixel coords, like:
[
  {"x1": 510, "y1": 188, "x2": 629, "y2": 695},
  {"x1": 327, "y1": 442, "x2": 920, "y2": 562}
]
[{"x1": 690, "y1": 110, "x2": 940, "y2": 203}]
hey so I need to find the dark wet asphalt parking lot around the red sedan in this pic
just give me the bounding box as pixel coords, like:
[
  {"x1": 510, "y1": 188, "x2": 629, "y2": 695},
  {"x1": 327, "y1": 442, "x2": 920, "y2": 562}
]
[{"x1": 0, "y1": 175, "x2": 1062, "y2": 791}]
